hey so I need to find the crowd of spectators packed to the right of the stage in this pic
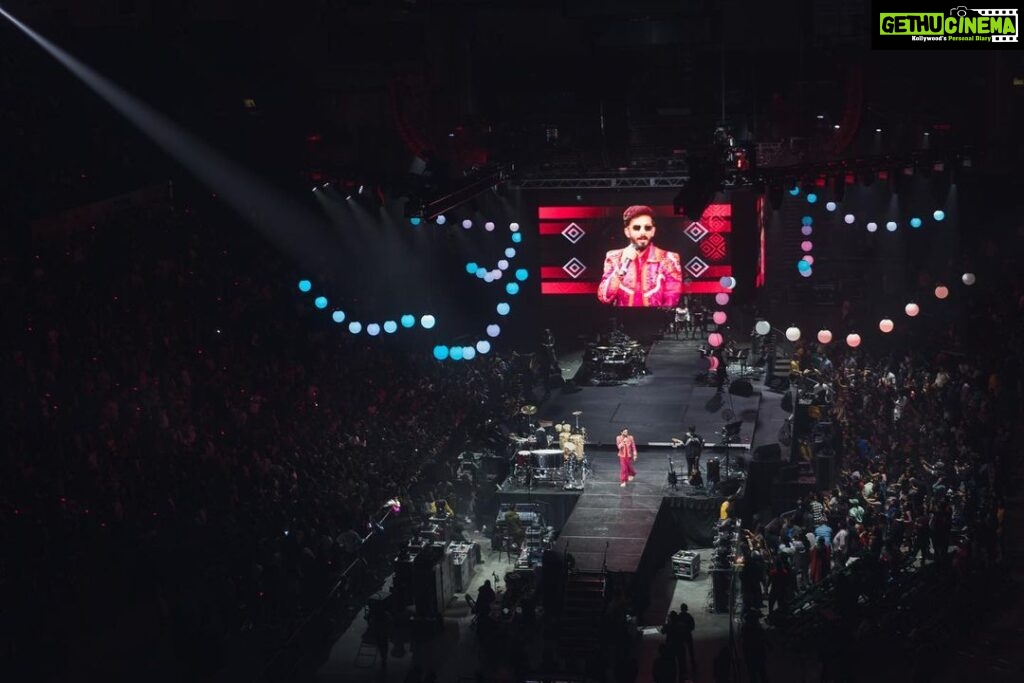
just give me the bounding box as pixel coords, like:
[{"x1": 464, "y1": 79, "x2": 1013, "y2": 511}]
[{"x1": 742, "y1": 223, "x2": 1024, "y2": 679}]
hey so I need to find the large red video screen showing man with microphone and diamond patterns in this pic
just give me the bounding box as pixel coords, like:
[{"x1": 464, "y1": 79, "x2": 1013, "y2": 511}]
[{"x1": 537, "y1": 194, "x2": 733, "y2": 308}]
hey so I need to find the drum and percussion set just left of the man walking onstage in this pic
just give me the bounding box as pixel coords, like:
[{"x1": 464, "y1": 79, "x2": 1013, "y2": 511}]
[{"x1": 509, "y1": 405, "x2": 590, "y2": 489}]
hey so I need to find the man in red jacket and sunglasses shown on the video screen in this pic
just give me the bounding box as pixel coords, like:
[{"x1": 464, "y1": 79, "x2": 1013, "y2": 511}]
[{"x1": 597, "y1": 205, "x2": 683, "y2": 307}]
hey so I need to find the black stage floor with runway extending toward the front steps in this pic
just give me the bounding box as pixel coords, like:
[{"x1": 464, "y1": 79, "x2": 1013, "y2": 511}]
[{"x1": 500, "y1": 340, "x2": 761, "y2": 572}]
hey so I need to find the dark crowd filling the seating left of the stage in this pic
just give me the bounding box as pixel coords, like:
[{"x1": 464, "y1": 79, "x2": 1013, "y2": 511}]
[{"x1": 0, "y1": 198, "x2": 519, "y2": 680}]
